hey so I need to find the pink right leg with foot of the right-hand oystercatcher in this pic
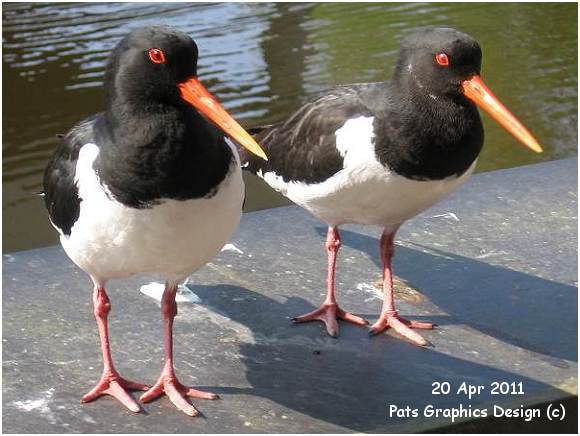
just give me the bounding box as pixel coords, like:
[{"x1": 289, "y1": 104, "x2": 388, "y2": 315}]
[{"x1": 370, "y1": 230, "x2": 433, "y2": 346}]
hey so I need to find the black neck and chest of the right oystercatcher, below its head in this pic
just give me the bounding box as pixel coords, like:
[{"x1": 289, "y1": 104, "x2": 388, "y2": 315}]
[{"x1": 375, "y1": 82, "x2": 483, "y2": 180}]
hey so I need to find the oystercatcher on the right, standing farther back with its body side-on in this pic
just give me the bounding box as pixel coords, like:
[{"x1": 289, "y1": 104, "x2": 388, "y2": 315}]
[{"x1": 242, "y1": 28, "x2": 542, "y2": 345}]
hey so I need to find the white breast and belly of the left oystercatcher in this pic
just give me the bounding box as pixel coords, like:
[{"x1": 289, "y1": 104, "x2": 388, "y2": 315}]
[{"x1": 60, "y1": 144, "x2": 244, "y2": 281}]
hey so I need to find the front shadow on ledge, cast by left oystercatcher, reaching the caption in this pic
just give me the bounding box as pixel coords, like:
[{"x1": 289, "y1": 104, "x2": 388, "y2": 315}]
[{"x1": 191, "y1": 285, "x2": 573, "y2": 432}]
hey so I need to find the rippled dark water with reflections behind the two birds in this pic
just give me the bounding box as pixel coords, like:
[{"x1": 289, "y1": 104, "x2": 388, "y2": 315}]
[{"x1": 2, "y1": 3, "x2": 578, "y2": 252}]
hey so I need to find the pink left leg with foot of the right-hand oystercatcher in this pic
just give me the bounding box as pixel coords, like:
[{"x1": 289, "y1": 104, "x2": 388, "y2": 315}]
[{"x1": 294, "y1": 227, "x2": 368, "y2": 337}]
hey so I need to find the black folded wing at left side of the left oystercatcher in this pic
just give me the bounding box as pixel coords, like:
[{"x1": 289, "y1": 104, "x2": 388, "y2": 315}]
[{"x1": 44, "y1": 115, "x2": 99, "y2": 236}]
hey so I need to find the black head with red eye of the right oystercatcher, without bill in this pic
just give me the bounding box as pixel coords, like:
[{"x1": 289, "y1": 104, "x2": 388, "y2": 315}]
[{"x1": 394, "y1": 27, "x2": 481, "y2": 97}]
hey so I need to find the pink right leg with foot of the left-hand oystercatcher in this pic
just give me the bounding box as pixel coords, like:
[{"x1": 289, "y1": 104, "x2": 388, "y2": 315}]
[{"x1": 141, "y1": 284, "x2": 219, "y2": 416}]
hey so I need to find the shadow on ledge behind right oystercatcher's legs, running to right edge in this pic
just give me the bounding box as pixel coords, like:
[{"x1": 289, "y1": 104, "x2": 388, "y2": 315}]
[{"x1": 316, "y1": 227, "x2": 578, "y2": 367}]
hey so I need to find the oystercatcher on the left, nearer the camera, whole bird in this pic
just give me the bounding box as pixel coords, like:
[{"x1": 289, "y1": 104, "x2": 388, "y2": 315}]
[{"x1": 44, "y1": 26, "x2": 265, "y2": 416}]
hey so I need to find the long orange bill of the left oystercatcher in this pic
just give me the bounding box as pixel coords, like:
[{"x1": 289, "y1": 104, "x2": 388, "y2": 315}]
[{"x1": 178, "y1": 77, "x2": 268, "y2": 160}]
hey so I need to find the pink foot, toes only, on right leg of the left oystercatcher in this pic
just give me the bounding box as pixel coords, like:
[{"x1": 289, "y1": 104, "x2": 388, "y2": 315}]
[{"x1": 140, "y1": 373, "x2": 219, "y2": 416}]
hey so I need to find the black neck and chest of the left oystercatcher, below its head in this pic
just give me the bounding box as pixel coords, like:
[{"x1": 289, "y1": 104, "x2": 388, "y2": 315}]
[{"x1": 96, "y1": 99, "x2": 232, "y2": 207}]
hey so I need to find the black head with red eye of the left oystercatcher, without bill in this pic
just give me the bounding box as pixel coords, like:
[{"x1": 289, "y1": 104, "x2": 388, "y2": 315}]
[{"x1": 105, "y1": 26, "x2": 198, "y2": 104}]
